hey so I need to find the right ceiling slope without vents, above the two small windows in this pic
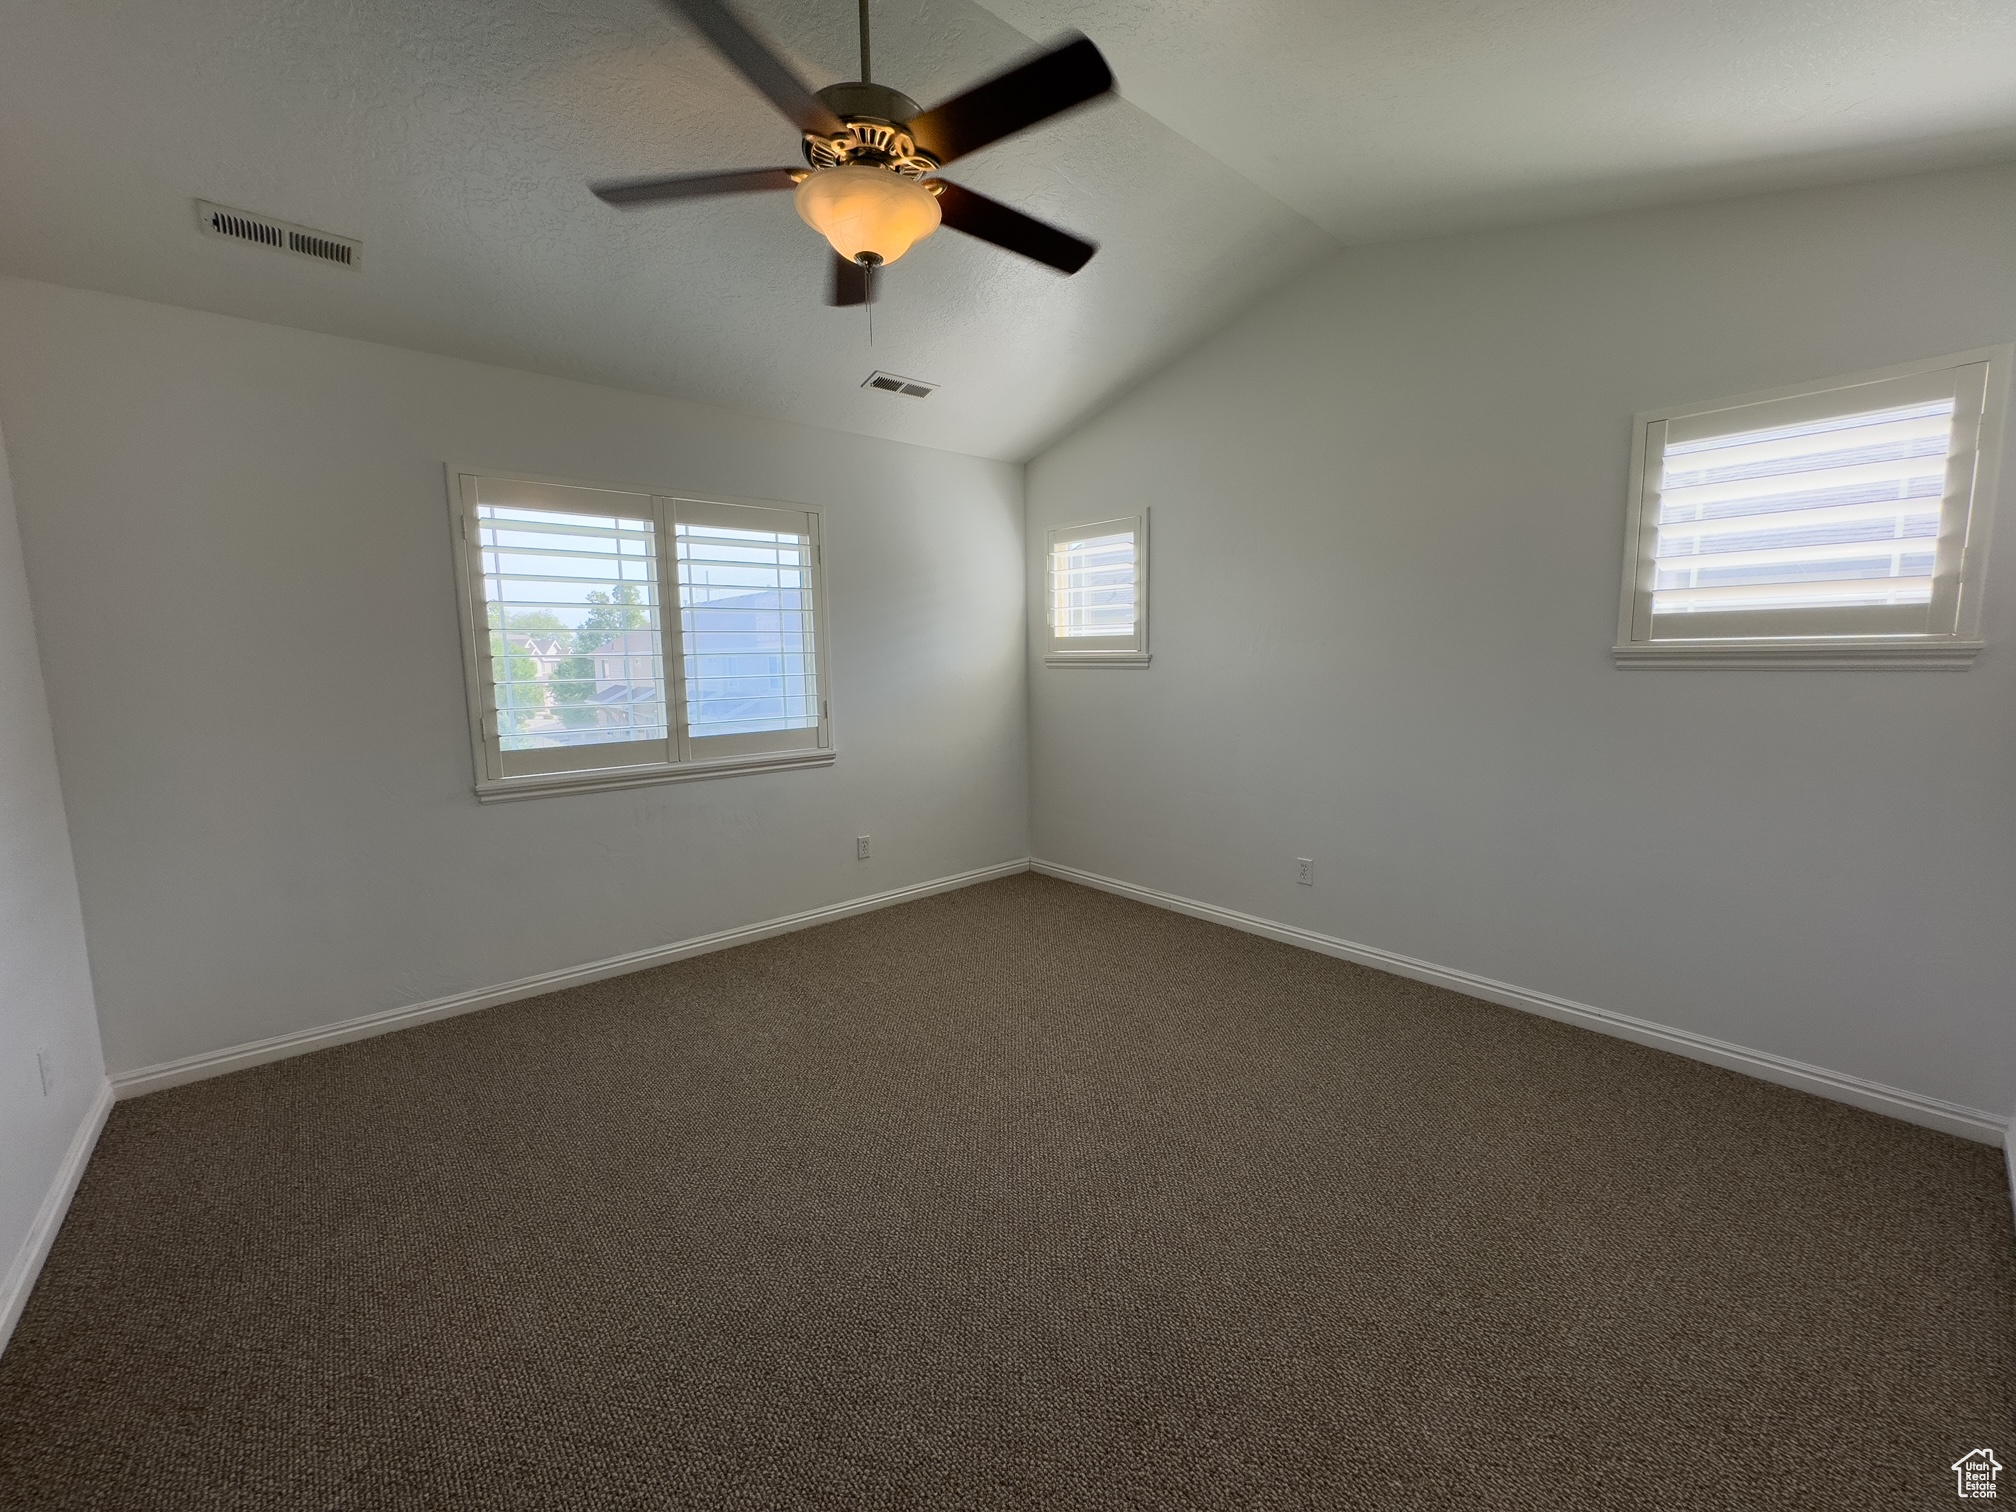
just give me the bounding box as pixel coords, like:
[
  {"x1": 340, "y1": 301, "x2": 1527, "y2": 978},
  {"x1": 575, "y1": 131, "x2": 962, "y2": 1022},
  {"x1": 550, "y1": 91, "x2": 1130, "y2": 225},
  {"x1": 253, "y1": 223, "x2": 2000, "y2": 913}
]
[{"x1": 988, "y1": 0, "x2": 2016, "y2": 242}]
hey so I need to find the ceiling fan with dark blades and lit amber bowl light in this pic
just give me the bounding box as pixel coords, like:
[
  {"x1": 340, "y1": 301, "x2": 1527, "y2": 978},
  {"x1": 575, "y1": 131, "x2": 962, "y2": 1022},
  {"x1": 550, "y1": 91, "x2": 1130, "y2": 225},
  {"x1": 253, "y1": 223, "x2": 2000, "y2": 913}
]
[{"x1": 589, "y1": 0, "x2": 1113, "y2": 304}]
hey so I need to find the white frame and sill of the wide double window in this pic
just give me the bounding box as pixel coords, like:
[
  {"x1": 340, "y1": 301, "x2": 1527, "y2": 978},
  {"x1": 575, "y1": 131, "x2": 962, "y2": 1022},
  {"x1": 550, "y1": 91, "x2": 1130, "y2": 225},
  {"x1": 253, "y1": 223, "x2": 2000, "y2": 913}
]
[{"x1": 446, "y1": 464, "x2": 839, "y2": 802}]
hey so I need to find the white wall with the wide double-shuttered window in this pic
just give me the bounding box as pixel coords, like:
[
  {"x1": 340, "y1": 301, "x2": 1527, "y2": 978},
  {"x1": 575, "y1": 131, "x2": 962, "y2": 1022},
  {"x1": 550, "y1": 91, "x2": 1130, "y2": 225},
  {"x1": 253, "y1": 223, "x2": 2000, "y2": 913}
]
[{"x1": 0, "y1": 280, "x2": 1026, "y2": 1075}]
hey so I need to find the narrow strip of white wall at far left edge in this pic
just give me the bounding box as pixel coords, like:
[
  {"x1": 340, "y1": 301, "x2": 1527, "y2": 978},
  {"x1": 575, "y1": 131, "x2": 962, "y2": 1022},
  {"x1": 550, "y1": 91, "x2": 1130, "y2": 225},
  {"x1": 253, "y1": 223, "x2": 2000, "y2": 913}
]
[{"x1": 0, "y1": 411, "x2": 105, "y2": 1347}]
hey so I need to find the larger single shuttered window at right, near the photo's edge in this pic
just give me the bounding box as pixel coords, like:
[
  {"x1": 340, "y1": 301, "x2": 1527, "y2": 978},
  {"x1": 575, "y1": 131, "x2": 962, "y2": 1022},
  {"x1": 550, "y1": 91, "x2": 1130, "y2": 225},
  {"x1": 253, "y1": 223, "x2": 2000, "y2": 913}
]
[{"x1": 1615, "y1": 347, "x2": 2010, "y2": 667}]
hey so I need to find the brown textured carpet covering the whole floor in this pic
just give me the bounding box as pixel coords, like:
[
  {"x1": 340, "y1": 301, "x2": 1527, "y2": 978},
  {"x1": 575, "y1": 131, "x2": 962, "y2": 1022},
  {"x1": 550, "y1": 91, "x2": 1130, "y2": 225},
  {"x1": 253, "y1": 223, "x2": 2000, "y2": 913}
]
[{"x1": 0, "y1": 877, "x2": 2016, "y2": 1512}]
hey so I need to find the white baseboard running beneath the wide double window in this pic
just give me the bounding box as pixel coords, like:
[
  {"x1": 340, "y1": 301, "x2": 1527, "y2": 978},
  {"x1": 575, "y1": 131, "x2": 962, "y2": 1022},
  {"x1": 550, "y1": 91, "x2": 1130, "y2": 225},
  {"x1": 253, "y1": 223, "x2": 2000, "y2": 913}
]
[{"x1": 111, "y1": 857, "x2": 1028, "y2": 1097}]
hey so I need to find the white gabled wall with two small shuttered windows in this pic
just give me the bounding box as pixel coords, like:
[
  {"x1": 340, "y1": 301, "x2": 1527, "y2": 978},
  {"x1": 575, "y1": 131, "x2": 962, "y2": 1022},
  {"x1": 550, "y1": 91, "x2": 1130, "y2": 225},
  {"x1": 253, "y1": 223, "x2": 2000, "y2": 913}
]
[{"x1": 1028, "y1": 167, "x2": 2016, "y2": 1111}]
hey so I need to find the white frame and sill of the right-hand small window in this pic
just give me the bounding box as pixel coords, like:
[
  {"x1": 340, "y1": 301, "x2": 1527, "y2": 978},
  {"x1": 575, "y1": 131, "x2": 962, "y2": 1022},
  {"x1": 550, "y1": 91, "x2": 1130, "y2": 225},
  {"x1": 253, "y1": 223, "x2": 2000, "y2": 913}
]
[{"x1": 1611, "y1": 345, "x2": 2016, "y2": 671}]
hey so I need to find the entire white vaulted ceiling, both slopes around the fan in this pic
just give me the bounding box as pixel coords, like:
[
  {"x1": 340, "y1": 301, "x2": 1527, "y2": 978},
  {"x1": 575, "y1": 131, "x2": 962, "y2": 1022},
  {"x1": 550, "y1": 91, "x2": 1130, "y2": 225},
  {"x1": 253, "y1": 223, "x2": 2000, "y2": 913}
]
[{"x1": 0, "y1": 0, "x2": 2016, "y2": 458}]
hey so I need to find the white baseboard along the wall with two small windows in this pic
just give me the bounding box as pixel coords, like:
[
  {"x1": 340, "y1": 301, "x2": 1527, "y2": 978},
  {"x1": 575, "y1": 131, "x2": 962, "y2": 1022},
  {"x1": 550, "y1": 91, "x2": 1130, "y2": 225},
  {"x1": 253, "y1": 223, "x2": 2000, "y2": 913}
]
[{"x1": 1028, "y1": 861, "x2": 2016, "y2": 1145}]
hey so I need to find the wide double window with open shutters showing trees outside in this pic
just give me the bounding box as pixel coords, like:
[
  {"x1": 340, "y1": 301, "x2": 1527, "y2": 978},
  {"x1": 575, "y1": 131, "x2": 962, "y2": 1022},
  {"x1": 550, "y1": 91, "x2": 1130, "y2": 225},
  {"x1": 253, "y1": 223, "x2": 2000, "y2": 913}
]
[{"x1": 454, "y1": 474, "x2": 833, "y2": 800}]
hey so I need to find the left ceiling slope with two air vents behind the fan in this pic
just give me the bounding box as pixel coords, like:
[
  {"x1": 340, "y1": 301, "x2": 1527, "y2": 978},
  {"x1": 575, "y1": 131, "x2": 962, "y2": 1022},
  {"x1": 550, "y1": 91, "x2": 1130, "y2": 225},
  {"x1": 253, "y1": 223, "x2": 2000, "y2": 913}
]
[{"x1": 0, "y1": 0, "x2": 1335, "y2": 458}]
